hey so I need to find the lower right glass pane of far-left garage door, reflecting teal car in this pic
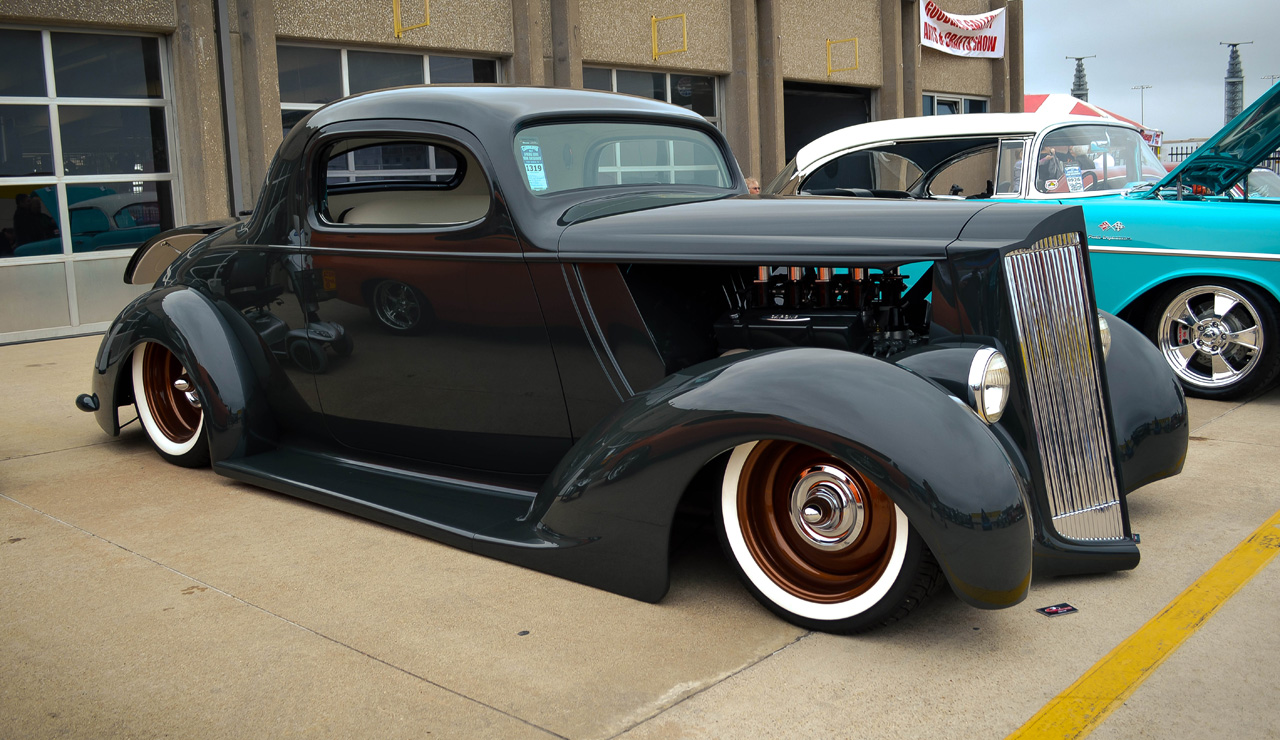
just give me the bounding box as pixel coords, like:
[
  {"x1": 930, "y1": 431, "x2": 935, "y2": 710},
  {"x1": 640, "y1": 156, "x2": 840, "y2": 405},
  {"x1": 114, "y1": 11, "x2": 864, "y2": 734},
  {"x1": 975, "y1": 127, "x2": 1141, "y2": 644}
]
[{"x1": 67, "y1": 182, "x2": 173, "y2": 253}]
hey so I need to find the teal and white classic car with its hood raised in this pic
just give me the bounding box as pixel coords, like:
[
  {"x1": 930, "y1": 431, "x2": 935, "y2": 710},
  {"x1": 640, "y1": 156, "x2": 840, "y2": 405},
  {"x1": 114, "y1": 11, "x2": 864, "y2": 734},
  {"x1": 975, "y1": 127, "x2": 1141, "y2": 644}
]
[{"x1": 764, "y1": 86, "x2": 1280, "y2": 399}]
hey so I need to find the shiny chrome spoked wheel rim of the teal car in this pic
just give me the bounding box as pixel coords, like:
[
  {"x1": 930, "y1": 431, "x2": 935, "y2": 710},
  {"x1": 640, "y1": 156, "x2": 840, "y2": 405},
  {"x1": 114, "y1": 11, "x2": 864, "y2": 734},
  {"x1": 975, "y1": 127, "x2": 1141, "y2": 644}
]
[{"x1": 1160, "y1": 286, "x2": 1263, "y2": 388}]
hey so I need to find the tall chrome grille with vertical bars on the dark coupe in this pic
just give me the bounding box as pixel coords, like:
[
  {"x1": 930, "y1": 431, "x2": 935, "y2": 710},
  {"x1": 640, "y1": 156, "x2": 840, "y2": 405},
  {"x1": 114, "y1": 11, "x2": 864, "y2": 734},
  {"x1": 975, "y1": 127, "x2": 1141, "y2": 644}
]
[{"x1": 1005, "y1": 233, "x2": 1124, "y2": 539}]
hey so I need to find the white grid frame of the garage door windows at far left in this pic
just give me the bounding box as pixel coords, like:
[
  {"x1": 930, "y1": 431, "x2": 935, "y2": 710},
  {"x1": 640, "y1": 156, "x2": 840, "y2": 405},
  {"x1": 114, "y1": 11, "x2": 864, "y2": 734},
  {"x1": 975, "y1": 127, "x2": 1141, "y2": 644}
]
[{"x1": 0, "y1": 23, "x2": 186, "y2": 343}]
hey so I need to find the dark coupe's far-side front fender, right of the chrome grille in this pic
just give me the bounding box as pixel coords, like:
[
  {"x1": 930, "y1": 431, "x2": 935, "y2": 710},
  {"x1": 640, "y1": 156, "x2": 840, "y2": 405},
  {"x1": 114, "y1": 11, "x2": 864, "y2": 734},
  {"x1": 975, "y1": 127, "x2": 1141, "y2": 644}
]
[{"x1": 1106, "y1": 308, "x2": 1190, "y2": 494}]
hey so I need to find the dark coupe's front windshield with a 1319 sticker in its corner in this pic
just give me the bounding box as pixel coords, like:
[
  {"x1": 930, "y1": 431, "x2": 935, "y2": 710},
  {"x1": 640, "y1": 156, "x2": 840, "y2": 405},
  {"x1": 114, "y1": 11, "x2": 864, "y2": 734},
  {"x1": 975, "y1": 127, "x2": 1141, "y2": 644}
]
[{"x1": 515, "y1": 122, "x2": 733, "y2": 195}]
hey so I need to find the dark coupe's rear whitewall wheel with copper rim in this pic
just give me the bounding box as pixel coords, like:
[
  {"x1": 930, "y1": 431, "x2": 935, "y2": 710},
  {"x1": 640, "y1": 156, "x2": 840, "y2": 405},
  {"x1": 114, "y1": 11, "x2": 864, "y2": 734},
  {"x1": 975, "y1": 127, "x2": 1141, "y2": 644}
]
[{"x1": 133, "y1": 342, "x2": 209, "y2": 467}]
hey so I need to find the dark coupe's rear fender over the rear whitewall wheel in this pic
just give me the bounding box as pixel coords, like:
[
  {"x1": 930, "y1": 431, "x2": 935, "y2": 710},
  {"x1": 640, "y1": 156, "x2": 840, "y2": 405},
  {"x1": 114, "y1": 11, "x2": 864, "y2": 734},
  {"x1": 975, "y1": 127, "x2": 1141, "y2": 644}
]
[{"x1": 93, "y1": 286, "x2": 275, "y2": 462}]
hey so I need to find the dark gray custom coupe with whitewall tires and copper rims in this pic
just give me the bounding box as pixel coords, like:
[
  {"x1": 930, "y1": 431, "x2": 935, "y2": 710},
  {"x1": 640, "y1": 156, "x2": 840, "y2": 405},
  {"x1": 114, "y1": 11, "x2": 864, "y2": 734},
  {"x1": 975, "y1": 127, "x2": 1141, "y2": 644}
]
[{"x1": 77, "y1": 87, "x2": 1188, "y2": 631}]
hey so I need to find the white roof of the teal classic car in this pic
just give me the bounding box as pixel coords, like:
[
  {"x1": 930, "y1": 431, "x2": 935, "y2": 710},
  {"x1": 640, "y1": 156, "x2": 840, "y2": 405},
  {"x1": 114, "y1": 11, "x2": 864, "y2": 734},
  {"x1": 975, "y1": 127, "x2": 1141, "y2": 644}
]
[{"x1": 796, "y1": 113, "x2": 1138, "y2": 172}]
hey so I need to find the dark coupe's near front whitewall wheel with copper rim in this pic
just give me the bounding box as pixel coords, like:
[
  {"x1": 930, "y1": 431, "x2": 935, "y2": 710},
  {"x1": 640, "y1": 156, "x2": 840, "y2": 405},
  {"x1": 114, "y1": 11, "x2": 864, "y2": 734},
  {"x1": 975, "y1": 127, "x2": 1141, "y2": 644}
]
[{"x1": 719, "y1": 440, "x2": 942, "y2": 632}]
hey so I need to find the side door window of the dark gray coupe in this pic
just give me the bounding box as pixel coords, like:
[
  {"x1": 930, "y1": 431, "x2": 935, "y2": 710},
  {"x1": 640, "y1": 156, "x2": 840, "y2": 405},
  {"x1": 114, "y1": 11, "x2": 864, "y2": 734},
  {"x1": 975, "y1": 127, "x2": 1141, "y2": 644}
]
[{"x1": 317, "y1": 138, "x2": 492, "y2": 227}]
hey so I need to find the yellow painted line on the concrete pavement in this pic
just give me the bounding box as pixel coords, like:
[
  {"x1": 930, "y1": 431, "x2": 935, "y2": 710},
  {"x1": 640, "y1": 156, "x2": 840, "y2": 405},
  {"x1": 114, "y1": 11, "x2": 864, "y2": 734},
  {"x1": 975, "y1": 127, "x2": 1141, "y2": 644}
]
[{"x1": 1007, "y1": 511, "x2": 1280, "y2": 740}]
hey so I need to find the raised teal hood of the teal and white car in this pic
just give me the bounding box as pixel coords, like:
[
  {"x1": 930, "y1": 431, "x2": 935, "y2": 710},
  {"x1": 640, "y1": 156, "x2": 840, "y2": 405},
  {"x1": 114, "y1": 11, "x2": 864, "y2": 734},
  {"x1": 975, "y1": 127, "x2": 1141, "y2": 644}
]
[{"x1": 1147, "y1": 84, "x2": 1280, "y2": 197}]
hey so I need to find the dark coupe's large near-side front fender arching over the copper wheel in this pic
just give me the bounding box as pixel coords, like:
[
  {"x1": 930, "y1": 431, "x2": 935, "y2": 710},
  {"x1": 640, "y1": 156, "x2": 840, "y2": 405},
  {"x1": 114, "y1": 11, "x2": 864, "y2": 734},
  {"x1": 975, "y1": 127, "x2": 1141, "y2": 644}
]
[{"x1": 499, "y1": 348, "x2": 1032, "y2": 608}]
